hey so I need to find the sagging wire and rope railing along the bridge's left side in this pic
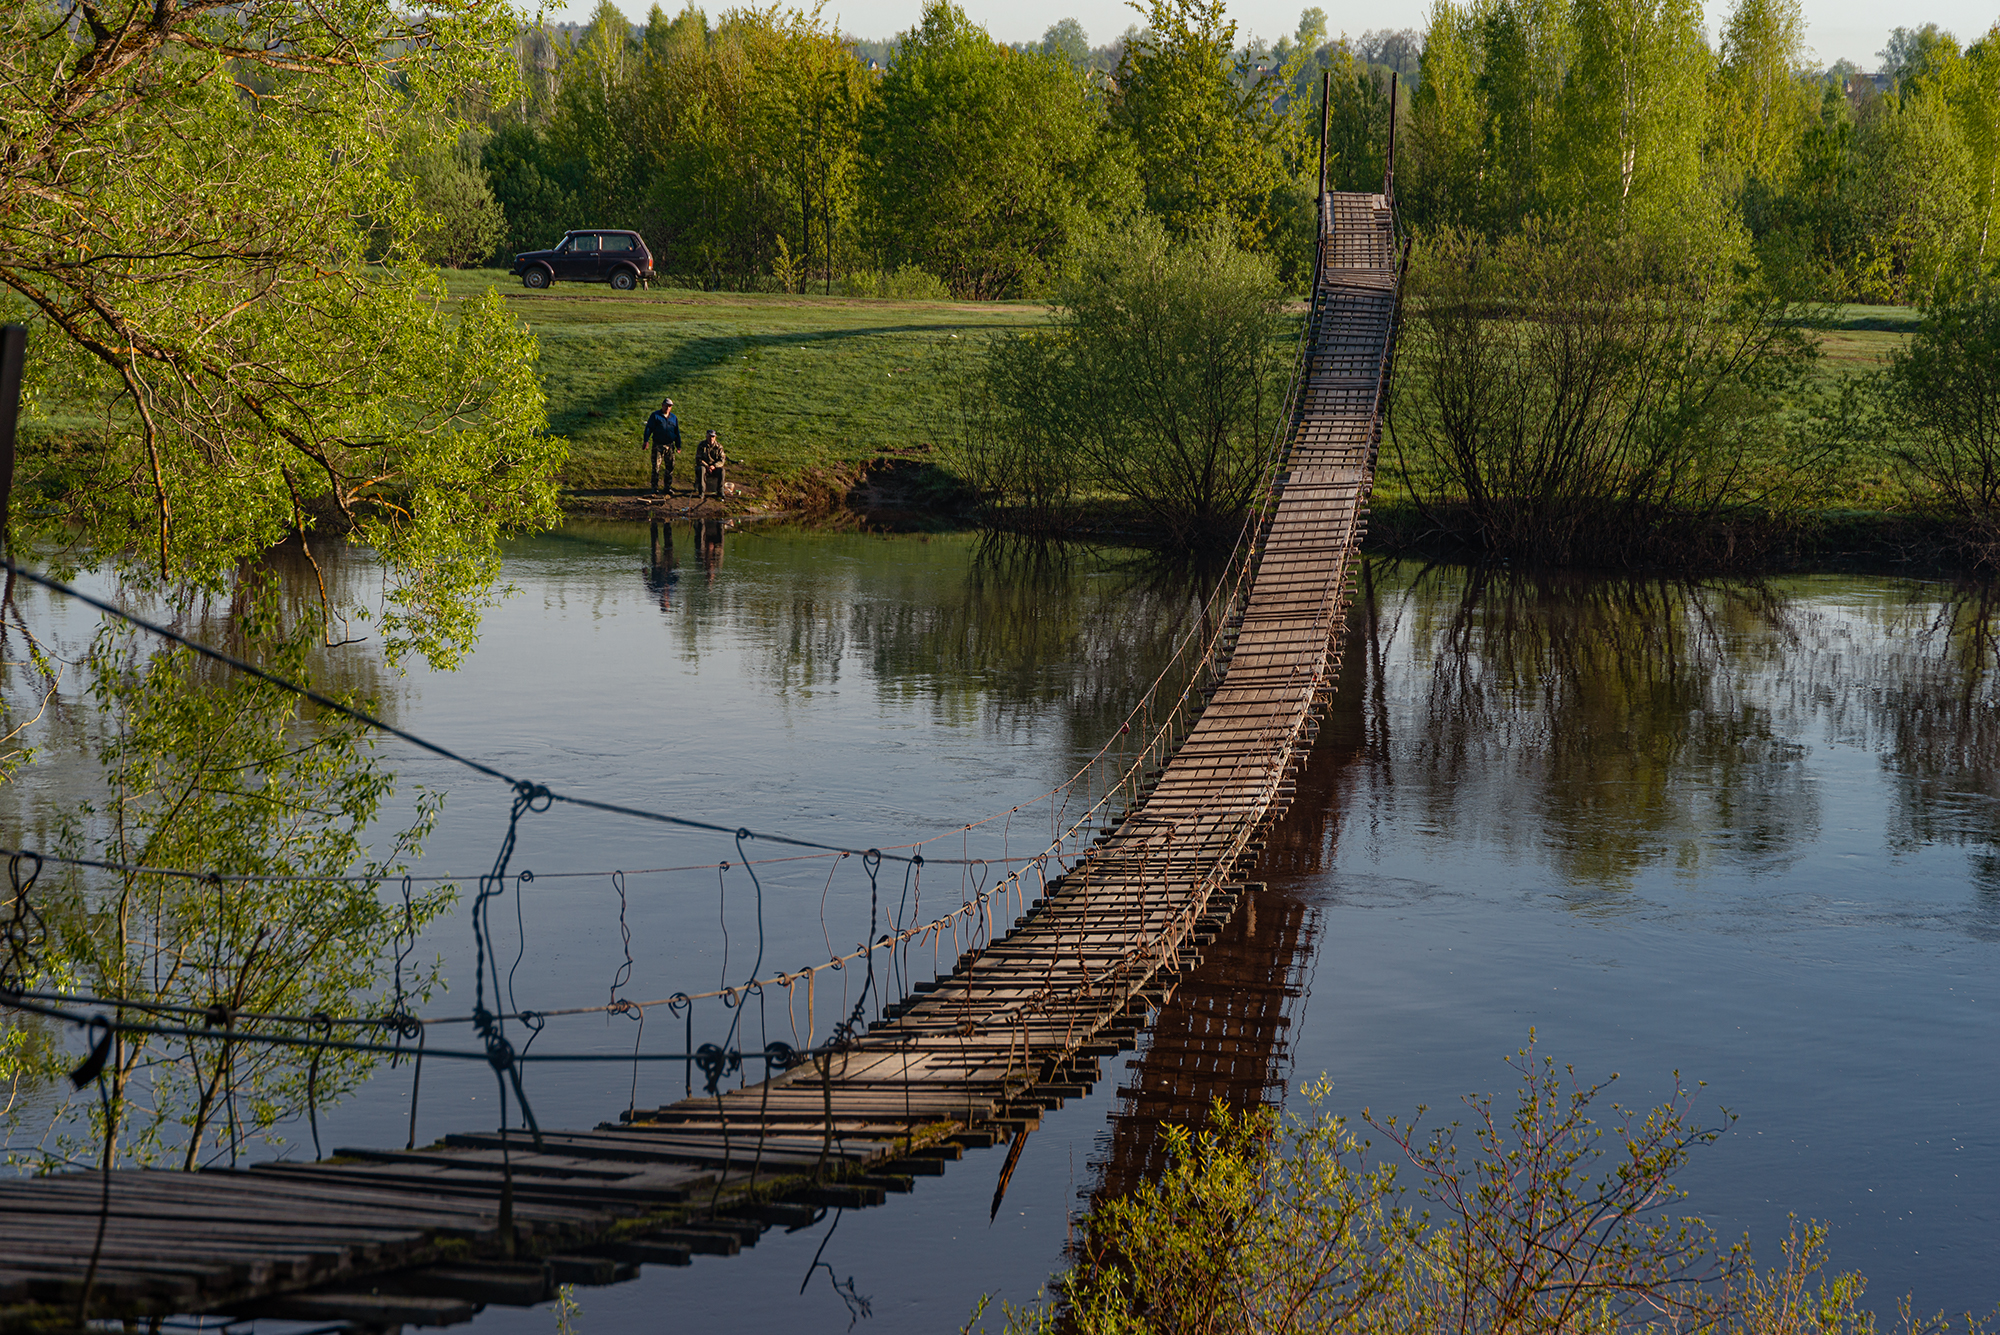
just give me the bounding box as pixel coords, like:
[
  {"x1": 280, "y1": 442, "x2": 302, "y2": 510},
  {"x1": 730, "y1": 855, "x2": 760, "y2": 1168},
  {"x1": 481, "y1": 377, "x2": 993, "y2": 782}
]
[{"x1": 0, "y1": 169, "x2": 1408, "y2": 1167}]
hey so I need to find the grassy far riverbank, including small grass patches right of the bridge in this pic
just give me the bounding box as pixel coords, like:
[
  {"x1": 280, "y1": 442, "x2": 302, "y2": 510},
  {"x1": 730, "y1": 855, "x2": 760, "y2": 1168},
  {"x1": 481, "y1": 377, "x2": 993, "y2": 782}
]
[{"x1": 28, "y1": 270, "x2": 1928, "y2": 564}]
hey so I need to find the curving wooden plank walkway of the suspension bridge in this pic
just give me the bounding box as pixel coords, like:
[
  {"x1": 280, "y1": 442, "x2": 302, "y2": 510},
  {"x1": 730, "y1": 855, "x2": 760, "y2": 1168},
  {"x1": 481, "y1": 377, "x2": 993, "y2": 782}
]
[{"x1": 0, "y1": 194, "x2": 1400, "y2": 1331}]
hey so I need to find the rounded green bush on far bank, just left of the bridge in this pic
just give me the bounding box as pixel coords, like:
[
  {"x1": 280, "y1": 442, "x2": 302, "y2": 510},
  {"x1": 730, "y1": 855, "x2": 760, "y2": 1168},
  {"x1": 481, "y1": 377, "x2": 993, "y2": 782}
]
[{"x1": 990, "y1": 218, "x2": 1290, "y2": 546}]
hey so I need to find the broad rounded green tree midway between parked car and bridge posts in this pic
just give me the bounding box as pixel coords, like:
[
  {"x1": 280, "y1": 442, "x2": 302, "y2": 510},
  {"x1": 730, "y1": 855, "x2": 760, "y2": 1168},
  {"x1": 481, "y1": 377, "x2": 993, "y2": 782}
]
[{"x1": 860, "y1": 0, "x2": 1136, "y2": 298}]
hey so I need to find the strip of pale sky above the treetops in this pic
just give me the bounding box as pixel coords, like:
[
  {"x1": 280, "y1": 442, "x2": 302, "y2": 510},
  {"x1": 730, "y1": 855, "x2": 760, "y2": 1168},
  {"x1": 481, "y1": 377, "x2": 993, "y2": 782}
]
[{"x1": 550, "y1": 0, "x2": 2000, "y2": 70}]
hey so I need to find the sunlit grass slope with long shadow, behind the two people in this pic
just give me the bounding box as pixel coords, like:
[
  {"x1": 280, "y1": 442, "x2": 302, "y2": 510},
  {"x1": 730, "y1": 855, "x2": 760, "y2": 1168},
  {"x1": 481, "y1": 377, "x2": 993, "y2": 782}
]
[{"x1": 450, "y1": 270, "x2": 1044, "y2": 488}]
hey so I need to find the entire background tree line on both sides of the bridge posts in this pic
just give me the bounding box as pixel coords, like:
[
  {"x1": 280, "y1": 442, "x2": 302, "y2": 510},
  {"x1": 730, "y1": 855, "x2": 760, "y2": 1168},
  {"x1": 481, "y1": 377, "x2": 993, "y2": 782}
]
[{"x1": 404, "y1": 0, "x2": 2000, "y2": 302}]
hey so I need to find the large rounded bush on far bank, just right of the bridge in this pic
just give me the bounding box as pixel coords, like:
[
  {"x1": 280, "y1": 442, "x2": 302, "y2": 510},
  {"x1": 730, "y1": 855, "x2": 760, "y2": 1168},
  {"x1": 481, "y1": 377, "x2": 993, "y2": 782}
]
[{"x1": 1390, "y1": 216, "x2": 1844, "y2": 564}]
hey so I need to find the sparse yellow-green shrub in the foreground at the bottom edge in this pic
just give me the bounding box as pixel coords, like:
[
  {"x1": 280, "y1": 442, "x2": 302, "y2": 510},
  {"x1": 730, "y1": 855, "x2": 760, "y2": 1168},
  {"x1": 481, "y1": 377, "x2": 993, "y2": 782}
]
[{"x1": 1010, "y1": 1035, "x2": 1740, "y2": 1335}]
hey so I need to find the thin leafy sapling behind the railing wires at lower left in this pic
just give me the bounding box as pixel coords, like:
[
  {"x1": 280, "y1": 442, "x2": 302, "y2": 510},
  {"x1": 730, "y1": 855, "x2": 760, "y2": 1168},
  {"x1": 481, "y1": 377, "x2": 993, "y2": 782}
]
[{"x1": 0, "y1": 592, "x2": 452, "y2": 1167}]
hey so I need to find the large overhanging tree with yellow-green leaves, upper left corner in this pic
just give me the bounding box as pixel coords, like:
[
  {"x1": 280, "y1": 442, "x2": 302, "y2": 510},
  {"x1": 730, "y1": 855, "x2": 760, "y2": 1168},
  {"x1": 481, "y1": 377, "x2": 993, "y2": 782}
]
[{"x1": 0, "y1": 0, "x2": 562, "y2": 660}]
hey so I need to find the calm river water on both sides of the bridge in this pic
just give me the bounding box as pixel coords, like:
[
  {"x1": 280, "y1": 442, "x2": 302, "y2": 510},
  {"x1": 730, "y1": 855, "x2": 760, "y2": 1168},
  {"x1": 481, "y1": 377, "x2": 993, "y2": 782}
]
[{"x1": 11, "y1": 524, "x2": 2000, "y2": 1333}]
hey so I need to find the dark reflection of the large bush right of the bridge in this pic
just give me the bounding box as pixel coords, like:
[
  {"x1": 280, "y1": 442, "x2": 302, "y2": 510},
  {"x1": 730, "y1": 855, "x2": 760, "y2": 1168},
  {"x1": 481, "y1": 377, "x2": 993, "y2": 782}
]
[{"x1": 1362, "y1": 566, "x2": 1818, "y2": 907}]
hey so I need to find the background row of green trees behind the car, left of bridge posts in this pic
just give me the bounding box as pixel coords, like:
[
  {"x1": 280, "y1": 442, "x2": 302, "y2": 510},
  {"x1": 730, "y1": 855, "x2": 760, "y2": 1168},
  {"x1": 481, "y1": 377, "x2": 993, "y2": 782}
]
[{"x1": 410, "y1": 0, "x2": 1414, "y2": 298}]
